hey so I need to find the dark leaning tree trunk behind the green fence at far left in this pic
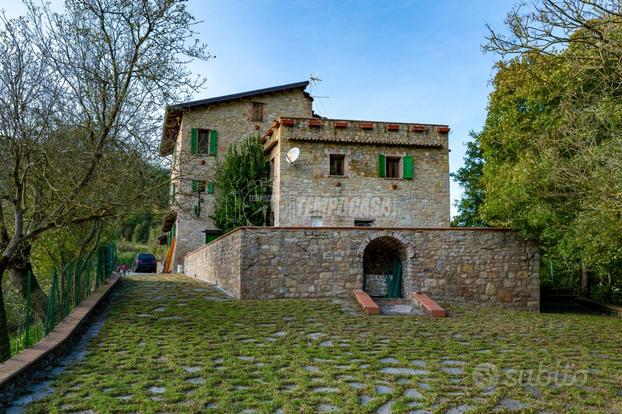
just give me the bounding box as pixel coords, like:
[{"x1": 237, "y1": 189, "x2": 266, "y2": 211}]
[{"x1": 9, "y1": 245, "x2": 48, "y2": 323}]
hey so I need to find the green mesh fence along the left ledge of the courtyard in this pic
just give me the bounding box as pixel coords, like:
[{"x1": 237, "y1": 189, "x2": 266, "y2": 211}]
[{"x1": 11, "y1": 243, "x2": 117, "y2": 354}]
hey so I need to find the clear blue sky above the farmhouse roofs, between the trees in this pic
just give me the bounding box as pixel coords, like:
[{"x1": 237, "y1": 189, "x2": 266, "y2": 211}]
[{"x1": 0, "y1": 0, "x2": 514, "y2": 215}]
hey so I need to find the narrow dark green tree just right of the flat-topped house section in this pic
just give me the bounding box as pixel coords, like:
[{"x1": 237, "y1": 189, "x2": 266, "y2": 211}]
[{"x1": 450, "y1": 131, "x2": 486, "y2": 227}]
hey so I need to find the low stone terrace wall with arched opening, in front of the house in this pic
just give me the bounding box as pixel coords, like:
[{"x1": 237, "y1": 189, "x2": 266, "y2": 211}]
[{"x1": 185, "y1": 227, "x2": 539, "y2": 310}]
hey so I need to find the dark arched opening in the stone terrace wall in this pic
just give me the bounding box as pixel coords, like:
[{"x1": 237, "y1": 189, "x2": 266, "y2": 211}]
[{"x1": 363, "y1": 236, "x2": 406, "y2": 298}]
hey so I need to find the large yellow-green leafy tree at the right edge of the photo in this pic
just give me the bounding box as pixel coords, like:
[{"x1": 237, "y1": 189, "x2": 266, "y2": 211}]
[{"x1": 479, "y1": 0, "x2": 622, "y2": 300}]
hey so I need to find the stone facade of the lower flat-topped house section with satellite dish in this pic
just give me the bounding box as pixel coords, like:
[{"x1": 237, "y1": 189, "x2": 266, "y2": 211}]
[{"x1": 265, "y1": 117, "x2": 450, "y2": 227}]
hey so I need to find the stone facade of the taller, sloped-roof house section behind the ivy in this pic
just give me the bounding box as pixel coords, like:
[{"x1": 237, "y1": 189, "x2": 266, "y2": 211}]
[{"x1": 166, "y1": 87, "x2": 312, "y2": 269}]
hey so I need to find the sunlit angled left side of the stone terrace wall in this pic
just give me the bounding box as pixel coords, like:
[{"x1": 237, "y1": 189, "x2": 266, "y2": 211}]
[{"x1": 184, "y1": 230, "x2": 242, "y2": 298}]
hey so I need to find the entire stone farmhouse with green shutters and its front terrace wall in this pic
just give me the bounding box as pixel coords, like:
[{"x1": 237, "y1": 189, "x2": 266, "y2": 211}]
[{"x1": 160, "y1": 82, "x2": 539, "y2": 310}]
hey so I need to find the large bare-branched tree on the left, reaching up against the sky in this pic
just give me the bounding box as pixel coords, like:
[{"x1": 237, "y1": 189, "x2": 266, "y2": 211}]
[{"x1": 0, "y1": 0, "x2": 210, "y2": 359}]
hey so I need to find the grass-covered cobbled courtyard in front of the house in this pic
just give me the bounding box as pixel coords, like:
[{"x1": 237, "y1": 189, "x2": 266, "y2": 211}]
[{"x1": 20, "y1": 276, "x2": 622, "y2": 413}]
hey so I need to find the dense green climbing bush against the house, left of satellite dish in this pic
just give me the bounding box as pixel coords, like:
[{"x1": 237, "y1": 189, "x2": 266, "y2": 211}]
[{"x1": 211, "y1": 136, "x2": 272, "y2": 232}]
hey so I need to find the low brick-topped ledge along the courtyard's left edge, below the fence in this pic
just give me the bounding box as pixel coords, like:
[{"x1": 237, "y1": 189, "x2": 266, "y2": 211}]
[{"x1": 0, "y1": 274, "x2": 121, "y2": 402}]
